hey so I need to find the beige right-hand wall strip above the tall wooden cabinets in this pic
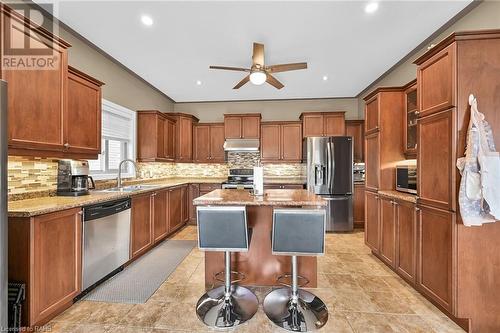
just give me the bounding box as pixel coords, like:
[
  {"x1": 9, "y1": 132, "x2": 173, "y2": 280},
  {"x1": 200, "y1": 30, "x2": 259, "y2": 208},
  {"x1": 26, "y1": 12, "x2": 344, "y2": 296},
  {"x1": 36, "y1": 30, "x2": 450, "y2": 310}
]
[{"x1": 358, "y1": 1, "x2": 500, "y2": 114}]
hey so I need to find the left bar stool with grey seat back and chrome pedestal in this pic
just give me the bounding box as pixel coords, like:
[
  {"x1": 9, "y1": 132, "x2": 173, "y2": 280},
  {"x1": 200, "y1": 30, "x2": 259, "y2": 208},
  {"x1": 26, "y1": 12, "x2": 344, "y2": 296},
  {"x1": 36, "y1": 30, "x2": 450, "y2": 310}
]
[{"x1": 196, "y1": 206, "x2": 259, "y2": 328}]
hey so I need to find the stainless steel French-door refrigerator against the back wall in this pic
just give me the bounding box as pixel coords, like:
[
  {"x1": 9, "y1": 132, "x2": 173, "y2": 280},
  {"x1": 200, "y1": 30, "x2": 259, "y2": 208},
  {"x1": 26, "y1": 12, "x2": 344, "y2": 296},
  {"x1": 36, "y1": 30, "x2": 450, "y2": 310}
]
[{"x1": 303, "y1": 136, "x2": 353, "y2": 231}]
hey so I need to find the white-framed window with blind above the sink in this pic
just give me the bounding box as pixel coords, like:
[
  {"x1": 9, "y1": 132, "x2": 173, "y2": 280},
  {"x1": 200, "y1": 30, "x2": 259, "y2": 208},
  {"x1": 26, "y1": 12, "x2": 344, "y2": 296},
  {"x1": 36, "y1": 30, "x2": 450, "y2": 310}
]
[{"x1": 89, "y1": 99, "x2": 136, "y2": 179}]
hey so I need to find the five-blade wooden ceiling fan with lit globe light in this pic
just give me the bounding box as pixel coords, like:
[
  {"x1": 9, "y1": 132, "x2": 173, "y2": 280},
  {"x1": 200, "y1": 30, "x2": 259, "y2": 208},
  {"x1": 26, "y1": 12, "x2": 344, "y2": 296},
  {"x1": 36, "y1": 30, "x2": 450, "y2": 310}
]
[{"x1": 210, "y1": 43, "x2": 307, "y2": 89}]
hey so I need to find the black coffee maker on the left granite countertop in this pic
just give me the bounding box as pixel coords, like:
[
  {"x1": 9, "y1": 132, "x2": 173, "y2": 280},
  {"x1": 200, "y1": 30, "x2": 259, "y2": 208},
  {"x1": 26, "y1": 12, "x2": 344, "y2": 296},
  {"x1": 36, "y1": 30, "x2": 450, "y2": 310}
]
[{"x1": 57, "y1": 160, "x2": 95, "y2": 197}]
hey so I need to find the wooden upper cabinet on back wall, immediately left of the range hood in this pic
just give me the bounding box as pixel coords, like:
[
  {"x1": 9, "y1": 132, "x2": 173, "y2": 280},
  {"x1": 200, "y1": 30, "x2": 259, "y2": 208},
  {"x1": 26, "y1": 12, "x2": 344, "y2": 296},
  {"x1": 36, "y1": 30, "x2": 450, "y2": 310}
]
[{"x1": 193, "y1": 124, "x2": 224, "y2": 163}]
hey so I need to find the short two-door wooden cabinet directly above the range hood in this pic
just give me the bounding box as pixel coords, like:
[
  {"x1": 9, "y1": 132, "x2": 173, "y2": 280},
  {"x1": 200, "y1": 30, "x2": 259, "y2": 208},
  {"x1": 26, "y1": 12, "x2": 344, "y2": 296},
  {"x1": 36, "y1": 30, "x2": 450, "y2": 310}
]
[{"x1": 224, "y1": 113, "x2": 261, "y2": 139}]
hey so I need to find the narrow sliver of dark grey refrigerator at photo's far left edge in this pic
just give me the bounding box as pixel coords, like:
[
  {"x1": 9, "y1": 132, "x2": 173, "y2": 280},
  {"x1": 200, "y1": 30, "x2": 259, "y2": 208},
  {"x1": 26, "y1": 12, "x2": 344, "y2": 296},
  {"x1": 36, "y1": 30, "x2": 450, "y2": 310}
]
[{"x1": 0, "y1": 80, "x2": 8, "y2": 332}]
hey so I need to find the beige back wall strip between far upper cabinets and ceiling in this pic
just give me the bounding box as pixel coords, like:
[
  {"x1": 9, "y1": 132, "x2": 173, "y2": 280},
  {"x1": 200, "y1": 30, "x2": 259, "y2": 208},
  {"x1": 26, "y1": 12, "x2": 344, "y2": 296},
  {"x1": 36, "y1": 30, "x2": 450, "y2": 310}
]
[{"x1": 174, "y1": 98, "x2": 359, "y2": 122}]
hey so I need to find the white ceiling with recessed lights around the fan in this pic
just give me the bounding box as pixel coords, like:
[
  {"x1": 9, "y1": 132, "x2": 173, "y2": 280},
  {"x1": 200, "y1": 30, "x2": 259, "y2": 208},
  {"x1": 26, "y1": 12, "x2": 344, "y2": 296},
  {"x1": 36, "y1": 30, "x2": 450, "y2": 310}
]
[{"x1": 38, "y1": 0, "x2": 471, "y2": 102}]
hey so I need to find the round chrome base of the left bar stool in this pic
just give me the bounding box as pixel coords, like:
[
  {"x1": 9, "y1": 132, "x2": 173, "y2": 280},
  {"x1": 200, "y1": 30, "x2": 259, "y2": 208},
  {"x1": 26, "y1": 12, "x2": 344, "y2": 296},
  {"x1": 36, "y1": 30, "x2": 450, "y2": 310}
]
[{"x1": 196, "y1": 285, "x2": 259, "y2": 329}]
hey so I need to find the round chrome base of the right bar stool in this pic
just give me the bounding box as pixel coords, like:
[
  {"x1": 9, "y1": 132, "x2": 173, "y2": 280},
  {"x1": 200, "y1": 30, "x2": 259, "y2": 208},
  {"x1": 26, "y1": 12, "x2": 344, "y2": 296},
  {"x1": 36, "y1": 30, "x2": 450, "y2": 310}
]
[{"x1": 263, "y1": 288, "x2": 328, "y2": 332}]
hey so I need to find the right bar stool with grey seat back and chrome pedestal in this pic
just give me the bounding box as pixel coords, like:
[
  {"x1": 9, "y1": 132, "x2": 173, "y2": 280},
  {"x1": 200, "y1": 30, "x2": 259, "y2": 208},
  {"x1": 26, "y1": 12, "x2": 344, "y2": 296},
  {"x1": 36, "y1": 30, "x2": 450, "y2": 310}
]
[{"x1": 263, "y1": 209, "x2": 328, "y2": 332}]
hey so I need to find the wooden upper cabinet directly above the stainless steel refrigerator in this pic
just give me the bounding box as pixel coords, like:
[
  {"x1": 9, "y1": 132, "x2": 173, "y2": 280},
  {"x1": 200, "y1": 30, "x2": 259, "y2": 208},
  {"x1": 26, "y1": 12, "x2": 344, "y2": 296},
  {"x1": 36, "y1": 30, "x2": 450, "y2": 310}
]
[{"x1": 300, "y1": 112, "x2": 345, "y2": 138}]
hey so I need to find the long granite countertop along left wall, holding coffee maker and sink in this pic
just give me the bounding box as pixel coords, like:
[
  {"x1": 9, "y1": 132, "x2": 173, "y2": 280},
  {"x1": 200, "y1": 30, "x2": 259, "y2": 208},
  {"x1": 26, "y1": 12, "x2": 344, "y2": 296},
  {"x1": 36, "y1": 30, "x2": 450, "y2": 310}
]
[{"x1": 8, "y1": 177, "x2": 226, "y2": 217}]
